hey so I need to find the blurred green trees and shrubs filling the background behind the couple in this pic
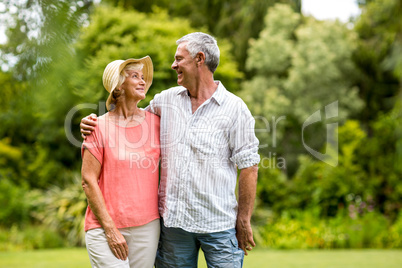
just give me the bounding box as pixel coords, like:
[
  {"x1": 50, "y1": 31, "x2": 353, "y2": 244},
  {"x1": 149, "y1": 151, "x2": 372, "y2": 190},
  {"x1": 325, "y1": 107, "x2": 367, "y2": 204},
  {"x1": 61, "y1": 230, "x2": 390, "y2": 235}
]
[{"x1": 0, "y1": 0, "x2": 402, "y2": 251}]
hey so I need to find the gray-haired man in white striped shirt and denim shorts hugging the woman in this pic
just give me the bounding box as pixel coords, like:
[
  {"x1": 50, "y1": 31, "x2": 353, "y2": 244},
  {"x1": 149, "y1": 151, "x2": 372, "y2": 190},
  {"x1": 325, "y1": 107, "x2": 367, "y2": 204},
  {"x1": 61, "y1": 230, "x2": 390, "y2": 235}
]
[{"x1": 81, "y1": 32, "x2": 260, "y2": 267}]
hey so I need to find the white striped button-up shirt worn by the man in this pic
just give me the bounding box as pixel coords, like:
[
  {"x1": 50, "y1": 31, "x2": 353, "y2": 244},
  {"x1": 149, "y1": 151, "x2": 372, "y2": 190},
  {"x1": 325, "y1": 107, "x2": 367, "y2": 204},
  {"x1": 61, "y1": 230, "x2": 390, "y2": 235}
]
[{"x1": 147, "y1": 82, "x2": 260, "y2": 233}]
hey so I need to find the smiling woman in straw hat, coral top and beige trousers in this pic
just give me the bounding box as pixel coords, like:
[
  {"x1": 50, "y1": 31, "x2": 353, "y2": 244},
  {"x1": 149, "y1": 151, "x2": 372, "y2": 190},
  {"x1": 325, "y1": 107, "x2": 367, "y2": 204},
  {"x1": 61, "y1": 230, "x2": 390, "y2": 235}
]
[{"x1": 82, "y1": 56, "x2": 160, "y2": 268}]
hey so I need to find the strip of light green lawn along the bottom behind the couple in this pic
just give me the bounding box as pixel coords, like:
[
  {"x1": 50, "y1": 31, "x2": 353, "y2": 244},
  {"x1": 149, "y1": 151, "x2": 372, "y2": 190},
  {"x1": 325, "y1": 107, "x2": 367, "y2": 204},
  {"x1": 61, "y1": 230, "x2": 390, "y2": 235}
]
[{"x1": 0, "y1": 248, "x2": 402, "y2": 268}]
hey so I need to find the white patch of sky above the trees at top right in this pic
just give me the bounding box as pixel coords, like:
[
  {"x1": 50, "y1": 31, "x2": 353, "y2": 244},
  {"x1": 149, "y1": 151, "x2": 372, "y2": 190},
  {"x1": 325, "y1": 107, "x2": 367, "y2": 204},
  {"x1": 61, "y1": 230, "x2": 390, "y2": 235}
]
[{"x1": 302, "y1": 0, "x2": 360, "y2": 22}]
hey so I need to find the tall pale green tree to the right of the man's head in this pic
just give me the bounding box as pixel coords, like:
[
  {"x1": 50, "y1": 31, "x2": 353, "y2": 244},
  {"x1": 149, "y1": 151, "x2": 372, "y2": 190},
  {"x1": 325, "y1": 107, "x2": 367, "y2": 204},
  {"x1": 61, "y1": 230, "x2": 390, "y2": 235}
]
[{"x1": 240, "y1": 4, "x2": 363, "y2": 174}]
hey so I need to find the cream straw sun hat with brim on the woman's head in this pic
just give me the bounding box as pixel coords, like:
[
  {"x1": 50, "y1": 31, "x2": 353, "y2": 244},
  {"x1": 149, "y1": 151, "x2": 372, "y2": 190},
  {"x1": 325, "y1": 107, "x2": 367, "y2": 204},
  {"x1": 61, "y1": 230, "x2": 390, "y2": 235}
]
[{"x1": 102, "y1": 56, "x2": 154, "y2": 110}]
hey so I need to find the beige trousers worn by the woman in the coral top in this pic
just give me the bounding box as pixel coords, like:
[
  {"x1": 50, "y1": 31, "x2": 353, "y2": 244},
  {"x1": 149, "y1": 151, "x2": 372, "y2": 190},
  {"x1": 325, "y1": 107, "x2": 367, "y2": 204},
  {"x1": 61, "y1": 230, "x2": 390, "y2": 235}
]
[{"x1": 85, "y1": 219, "x2": 160, "y2": 268}]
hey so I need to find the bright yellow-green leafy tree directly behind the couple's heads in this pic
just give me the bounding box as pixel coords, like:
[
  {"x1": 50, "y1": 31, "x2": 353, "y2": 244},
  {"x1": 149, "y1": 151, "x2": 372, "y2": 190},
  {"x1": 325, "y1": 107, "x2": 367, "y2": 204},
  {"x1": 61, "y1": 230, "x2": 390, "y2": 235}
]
[{"x1": 76, "y1": 6, "x2": 242, "y2": 113}]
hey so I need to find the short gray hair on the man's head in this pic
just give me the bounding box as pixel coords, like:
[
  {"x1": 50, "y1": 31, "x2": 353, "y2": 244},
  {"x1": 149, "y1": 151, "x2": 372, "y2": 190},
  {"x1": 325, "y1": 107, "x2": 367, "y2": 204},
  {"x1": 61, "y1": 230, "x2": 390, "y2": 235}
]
[{"x1": 176, "y1": 32, "x2": 220, "y2": 73}]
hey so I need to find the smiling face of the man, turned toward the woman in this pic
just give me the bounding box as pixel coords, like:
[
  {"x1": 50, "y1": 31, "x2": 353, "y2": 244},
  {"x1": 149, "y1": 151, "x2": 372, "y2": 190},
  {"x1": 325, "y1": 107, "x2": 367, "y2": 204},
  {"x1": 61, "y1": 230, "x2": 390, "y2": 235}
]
[{"x1": 172, "y1": 42, "x2": 197, "y2": 88}]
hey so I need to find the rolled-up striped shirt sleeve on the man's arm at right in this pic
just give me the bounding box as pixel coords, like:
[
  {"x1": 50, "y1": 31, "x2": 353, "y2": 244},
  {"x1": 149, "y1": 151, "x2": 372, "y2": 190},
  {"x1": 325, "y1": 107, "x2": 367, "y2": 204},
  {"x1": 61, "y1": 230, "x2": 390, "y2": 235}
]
[{"x1": 229, "y1": 102, "x2": 260, "y2": 169}]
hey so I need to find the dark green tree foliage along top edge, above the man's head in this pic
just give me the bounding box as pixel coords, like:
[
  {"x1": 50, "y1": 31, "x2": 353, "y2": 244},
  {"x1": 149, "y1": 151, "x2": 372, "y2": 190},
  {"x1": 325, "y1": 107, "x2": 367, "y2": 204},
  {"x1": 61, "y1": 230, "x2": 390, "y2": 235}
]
[{"x1": 103, "y1": 0, "x2": 301, "y2": 71}]
